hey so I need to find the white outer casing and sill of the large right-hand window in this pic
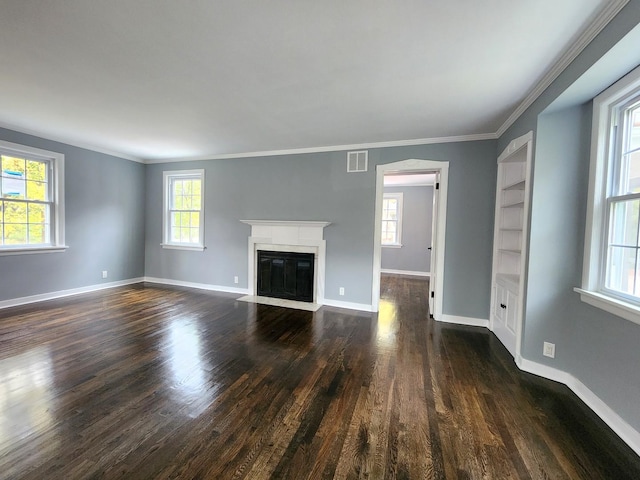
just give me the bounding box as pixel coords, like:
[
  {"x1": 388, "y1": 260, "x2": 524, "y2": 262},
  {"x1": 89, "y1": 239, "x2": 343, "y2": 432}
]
[{"x1": 574, "y1": 63, "x2": 640, "y2": 324}]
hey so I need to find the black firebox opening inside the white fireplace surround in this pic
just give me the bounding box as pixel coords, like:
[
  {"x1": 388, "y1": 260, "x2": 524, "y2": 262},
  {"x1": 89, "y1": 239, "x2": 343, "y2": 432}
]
[{"x1": 258, "y1": 250, "x2": 314, "y2": 302}]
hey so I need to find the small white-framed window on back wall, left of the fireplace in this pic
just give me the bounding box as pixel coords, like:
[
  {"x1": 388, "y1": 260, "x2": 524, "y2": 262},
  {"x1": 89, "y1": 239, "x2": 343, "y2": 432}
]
[{"x1": 162, "y1": 170, "x2": 204, "y2": 251}]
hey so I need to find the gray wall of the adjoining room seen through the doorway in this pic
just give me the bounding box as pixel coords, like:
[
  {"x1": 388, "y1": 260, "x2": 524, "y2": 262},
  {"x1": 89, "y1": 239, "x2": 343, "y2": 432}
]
[{"x1": 381, "y1": 186, "x2": 433, "y2": 272}]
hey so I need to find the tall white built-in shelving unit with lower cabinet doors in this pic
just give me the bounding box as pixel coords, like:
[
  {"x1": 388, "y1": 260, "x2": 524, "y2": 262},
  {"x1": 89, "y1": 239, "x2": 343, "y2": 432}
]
[{"x1": 490, "y1": 132, "x2": 533, "y2": 357}]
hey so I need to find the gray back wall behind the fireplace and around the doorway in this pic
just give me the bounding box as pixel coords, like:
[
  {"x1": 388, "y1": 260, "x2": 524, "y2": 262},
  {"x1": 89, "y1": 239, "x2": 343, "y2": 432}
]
[{"x1": 145, "y1": 141, "x2": 496, "y2": 319}]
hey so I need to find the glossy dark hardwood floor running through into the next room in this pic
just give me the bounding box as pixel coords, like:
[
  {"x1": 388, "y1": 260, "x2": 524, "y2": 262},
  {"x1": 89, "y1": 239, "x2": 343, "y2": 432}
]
[{"x1": 0, "y1": 277, "x2": 640, "y2": 480}]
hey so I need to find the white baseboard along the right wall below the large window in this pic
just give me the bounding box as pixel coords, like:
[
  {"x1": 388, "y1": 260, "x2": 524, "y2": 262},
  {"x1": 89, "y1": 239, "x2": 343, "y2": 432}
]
[{"x1": 516, "y1": 357, "x2": 640, "y2": 456}]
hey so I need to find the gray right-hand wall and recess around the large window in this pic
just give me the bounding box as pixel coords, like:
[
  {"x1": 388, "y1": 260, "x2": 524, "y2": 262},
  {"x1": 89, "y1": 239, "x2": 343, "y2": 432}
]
[{"x1": 498, "y1": 0, "x2": 640, "y2": 431}]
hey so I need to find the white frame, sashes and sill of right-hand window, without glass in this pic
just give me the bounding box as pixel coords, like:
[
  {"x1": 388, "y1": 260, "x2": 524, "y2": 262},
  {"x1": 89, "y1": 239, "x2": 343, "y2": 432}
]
[{"x1": 575, "y1": 63, "x2": 640, "y2": 324}]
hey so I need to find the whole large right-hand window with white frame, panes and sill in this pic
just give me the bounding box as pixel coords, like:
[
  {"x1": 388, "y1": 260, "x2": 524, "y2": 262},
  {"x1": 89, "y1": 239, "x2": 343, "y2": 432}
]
[{"x1": 577, "y1": 63, "x2": 640, "y2": 323}]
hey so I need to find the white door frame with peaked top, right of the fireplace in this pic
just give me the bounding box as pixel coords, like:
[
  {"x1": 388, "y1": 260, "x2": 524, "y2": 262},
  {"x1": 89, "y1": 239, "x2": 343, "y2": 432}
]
[{"x1": 372, "y1": 159, "x2": 449, "y2": 320}]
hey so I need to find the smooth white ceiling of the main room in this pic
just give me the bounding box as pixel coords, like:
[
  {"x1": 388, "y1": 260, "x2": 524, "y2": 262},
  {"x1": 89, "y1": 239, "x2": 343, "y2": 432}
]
[{"x1": 0, "y1": 0, "x2": 611, "y2": 161}]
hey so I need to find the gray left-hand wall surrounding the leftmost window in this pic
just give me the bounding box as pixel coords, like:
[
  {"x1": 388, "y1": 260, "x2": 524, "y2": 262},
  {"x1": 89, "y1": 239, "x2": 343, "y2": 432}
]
[{"x1": 0, "y1": 129, "x2": 145, "y2": 300}]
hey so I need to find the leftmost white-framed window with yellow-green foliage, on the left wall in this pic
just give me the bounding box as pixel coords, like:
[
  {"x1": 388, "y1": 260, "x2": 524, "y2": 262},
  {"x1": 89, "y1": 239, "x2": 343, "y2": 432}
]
[{"x1": 0, "y1": 141, "x2": 66, "y2": 255}]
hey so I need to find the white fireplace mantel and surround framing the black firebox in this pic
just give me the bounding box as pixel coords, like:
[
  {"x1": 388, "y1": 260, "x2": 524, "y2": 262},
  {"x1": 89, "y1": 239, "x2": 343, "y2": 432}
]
[{"x1": 240, "y1": 220, "x2": 331, "y2": 305}]
